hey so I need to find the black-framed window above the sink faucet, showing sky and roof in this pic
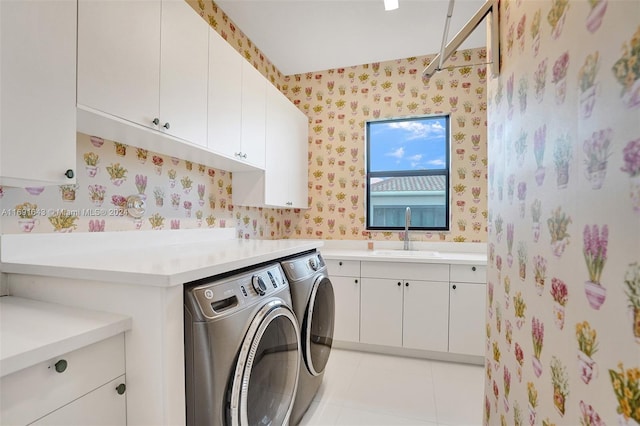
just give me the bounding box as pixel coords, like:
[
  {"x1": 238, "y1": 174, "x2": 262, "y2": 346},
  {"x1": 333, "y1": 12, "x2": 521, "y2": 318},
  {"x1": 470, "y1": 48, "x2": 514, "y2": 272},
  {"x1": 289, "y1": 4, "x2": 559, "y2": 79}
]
[{"x1": 365, "y1": 116, "x2": 449, "y2": 231}]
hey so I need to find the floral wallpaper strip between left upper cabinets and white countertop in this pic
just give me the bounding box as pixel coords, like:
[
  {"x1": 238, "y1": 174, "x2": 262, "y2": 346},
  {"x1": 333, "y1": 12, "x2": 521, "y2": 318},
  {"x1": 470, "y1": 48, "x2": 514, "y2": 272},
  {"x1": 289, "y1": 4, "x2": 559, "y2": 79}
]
[{"x1": 1, "y1": 133, "x2": 276, "y2": 238}]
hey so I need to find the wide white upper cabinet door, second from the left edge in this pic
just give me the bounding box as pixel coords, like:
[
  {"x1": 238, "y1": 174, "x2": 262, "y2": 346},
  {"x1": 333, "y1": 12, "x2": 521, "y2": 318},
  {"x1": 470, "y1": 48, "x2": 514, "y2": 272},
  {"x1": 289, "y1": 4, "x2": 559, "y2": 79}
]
[{"x1": 78, "y1": 0, "x2": 161, "y2": 128}]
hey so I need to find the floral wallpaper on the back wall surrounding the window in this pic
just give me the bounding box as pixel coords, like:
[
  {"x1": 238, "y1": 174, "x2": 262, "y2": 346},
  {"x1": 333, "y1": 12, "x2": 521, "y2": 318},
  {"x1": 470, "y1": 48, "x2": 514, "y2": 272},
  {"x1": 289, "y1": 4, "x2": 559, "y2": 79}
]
[{"x1": 281, "y1": 48, "x2": 487, "y2": 242}]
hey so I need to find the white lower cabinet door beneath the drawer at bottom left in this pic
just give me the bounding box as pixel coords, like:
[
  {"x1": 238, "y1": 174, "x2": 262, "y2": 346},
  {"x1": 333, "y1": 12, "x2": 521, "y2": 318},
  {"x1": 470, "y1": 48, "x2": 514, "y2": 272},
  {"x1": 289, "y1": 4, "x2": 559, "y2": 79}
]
[{"x1": 32, "y1": 375, "x2": 127, "y2": 426}]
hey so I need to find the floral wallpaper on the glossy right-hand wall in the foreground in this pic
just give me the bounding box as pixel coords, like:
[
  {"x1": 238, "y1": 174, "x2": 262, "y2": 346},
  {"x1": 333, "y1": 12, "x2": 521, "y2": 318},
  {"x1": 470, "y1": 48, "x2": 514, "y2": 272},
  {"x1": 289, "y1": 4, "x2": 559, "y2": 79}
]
[{"x1": 484, "y1": 0, "x2": 640, "y2": 426}]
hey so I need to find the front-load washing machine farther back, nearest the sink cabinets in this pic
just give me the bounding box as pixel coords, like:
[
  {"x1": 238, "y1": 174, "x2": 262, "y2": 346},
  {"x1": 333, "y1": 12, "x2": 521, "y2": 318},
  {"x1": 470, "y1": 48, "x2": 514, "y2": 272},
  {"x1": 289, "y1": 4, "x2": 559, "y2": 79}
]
[{"x1": 281, "y1": 251, "x2": 335, "y2": 425}]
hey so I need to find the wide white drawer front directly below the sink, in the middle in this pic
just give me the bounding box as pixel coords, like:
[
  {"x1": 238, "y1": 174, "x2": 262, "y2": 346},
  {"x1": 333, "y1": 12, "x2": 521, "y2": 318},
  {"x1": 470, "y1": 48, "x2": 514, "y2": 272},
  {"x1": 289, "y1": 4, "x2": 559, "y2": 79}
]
[{"x1": 360, "y1": 262, "x2": 449, "y2": 281}]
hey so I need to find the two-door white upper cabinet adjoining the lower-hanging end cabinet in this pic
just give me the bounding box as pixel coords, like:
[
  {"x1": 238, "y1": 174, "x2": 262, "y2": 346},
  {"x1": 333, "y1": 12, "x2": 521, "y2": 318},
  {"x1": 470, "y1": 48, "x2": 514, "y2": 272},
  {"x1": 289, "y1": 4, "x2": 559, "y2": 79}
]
[{"x1": 208, "y1": 30, "x2": 267, "y2": 169}]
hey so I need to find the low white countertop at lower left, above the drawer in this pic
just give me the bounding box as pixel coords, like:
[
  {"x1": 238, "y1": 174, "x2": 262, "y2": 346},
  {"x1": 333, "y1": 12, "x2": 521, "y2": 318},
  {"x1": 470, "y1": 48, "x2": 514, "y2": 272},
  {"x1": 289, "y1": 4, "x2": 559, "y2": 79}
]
[{"x1": 0, "y1": 296, "x2": 131, "y2": 377}]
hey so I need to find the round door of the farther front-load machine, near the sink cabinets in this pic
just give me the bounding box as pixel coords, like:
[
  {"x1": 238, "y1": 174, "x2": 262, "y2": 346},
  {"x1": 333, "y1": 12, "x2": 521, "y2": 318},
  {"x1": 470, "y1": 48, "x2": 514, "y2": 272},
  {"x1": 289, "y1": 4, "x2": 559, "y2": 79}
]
[{"x1": 302, "y1": 275, "x2": 335, "y2": 376}]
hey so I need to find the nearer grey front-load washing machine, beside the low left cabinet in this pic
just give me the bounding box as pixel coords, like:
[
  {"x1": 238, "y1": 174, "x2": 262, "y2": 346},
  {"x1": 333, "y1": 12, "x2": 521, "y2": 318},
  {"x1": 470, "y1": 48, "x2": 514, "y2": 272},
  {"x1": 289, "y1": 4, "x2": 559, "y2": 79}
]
[{"x1": 184, "y1": 263, "x2": 301, "y2": 426}]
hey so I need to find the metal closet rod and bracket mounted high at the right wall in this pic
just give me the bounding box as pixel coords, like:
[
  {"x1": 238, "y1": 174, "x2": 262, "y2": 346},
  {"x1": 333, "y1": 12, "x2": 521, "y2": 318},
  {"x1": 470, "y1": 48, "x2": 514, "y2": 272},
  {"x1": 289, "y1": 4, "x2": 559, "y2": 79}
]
[{"x1": 422, "y1": 0, "x2": 500, "y2": 77}]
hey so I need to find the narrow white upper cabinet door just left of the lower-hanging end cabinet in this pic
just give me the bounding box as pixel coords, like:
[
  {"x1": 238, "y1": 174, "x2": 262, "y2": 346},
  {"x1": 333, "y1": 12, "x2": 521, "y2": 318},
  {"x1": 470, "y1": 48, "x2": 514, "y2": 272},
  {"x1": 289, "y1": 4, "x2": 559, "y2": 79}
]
[{"x1": 240, "y1": 60, "x2": 267, "y2": 167}]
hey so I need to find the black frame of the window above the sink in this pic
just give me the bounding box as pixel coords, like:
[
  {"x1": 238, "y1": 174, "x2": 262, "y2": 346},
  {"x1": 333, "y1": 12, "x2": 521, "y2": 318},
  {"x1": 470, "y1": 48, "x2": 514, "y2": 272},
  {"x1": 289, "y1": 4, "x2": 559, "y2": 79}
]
[{"x1": 364, "y1": 114, "x2": 451, "y2": 232}]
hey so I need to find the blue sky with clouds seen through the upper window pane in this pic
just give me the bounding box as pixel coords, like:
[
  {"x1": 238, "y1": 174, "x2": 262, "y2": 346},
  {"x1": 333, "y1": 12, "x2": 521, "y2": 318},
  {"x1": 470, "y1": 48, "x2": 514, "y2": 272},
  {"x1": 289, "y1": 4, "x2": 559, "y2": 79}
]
[{"x1": 369, "y1": 117, "x2": 447, "y2": 171}]
